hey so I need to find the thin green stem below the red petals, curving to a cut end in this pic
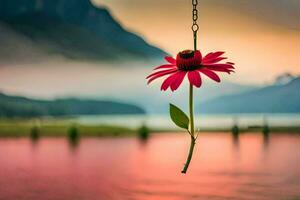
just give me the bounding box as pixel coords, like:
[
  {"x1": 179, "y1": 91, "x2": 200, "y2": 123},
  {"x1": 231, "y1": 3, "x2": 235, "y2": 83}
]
[{"x1": 181, "y1": 84, "x2": 196, "y2": 174}]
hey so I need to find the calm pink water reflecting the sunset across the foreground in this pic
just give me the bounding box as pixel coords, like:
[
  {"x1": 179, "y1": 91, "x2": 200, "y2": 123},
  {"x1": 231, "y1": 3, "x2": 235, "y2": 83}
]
[{"x1": 0, "y1": 133, "x2": 300, "y2": 200}]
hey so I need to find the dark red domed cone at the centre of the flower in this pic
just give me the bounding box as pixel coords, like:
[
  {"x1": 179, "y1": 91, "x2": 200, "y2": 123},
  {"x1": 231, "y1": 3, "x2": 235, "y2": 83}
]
[{"x1": 176, "y1": 50, "x2": 202, "y2": 71}]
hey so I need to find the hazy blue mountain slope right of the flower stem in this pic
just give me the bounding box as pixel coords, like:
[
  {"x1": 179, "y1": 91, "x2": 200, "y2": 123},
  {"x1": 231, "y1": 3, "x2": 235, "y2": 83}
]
[{"x1": 200, "y1": 77, "x2": 300, "y2": 113}]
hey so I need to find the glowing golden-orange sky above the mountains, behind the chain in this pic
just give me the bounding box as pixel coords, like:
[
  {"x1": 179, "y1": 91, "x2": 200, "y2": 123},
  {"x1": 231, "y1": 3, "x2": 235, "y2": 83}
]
[{"x1": 93, "y1": 0, "x2": 300, "y2": 83}]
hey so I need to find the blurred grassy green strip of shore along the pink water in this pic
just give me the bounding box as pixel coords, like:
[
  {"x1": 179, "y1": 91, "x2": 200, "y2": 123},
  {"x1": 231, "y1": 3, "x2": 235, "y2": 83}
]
[{"x1": 0, "y1": 120, "x2": 300, "y2": 138}]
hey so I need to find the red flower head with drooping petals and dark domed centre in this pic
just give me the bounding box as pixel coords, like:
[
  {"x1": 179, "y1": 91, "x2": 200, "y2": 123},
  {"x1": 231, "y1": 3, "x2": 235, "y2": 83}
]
[{"x1": 147, "y1": 50, "x2": 234, "y2": 91}]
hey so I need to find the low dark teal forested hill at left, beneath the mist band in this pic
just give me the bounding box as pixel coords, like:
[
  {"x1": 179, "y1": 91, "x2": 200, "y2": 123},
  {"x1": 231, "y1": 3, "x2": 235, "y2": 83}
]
[{"x1": 0, "y1": 93, "x2": 145, "y2": 117}]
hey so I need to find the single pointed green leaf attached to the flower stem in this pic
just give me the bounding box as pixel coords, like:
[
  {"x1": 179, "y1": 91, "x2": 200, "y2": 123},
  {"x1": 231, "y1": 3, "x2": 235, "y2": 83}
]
[{"x1": 170, "y1": 104, "x2": 190, "y2": 129}]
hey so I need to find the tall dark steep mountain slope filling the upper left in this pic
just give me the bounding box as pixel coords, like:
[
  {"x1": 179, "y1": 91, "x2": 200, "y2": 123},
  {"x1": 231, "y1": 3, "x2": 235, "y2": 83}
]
[{"x1": 0, "y1": 0, "x2": 166, "y2": 60}]
